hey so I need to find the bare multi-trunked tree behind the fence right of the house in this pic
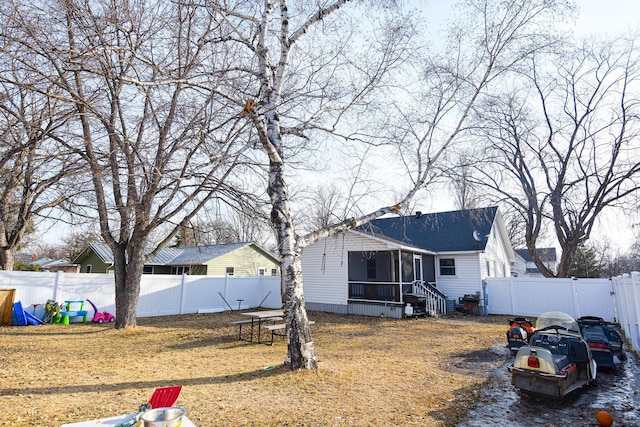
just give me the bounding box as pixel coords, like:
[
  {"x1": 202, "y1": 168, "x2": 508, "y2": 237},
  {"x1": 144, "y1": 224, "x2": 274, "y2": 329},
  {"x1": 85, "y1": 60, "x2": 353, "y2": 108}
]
[{"x1": 464, "y1": 39, "x2": 640, "y2": 277}]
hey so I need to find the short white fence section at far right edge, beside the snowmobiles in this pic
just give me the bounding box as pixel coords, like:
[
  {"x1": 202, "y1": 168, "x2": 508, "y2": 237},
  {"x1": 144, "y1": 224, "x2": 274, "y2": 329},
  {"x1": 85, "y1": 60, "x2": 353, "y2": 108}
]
[{"x1": 611, "y1": 271, "x2": 640, "y2": 351}]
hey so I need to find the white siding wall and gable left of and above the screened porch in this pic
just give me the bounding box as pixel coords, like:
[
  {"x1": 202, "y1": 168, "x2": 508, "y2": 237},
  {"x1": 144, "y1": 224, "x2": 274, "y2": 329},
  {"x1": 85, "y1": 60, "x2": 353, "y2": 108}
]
[{"x1": 302, "y1": 233, "x2": 390, "y2": 305}]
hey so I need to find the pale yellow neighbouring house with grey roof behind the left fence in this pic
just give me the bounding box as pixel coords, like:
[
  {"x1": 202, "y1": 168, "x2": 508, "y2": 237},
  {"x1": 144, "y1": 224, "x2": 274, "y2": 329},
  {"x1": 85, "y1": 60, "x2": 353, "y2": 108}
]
[{"x1": 74, "y1": 242, "x2": 280, "y2": 276}]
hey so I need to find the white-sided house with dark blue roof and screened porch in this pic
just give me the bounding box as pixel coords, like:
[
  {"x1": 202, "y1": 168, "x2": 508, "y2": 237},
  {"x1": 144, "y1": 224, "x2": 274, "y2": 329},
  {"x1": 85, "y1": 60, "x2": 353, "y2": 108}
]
[{"x1": 302, "y1": 206, "x2": 515, "y2": 318}]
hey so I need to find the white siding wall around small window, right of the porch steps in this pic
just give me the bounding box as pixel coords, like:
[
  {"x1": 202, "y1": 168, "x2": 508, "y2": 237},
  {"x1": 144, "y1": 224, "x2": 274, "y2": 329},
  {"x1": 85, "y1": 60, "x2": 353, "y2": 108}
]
[{"x1": 436, "y1": 254, "x2": 482, "y2": 301}]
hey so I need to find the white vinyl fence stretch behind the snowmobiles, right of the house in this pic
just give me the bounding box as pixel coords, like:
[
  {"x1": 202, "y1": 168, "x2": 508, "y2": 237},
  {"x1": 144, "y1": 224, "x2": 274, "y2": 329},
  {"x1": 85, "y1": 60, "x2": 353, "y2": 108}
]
[{"x1": 485, "y1": 277, "x2": 618, "y2": 322}]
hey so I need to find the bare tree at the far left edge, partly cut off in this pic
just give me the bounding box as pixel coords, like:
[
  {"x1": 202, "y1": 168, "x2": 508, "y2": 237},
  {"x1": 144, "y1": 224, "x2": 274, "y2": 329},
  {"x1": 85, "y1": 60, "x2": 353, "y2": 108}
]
[{"x1": 0, "y1": 57, "x2": 82, "y2": 270}]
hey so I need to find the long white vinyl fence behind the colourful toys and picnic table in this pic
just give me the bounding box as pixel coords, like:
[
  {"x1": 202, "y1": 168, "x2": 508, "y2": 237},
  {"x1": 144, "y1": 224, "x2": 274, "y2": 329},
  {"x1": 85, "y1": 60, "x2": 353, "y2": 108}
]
[{"x1": 0, "y1": 271, "x2": 282, "y2": 317}]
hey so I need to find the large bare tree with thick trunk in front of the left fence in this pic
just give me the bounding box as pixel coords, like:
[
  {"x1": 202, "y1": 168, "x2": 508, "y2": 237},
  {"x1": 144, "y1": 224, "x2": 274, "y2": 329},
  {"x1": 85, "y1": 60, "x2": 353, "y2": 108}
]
[{"x1": 1, "y1": 1, "x2": 255, "y2": 327}]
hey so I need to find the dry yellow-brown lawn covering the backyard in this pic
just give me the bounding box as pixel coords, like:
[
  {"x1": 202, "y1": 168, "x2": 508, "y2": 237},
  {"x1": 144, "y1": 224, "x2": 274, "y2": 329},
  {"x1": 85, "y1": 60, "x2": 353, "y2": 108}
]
[{"x1": 0, "y1": 312, "x2": 506, "y2": 427}]
